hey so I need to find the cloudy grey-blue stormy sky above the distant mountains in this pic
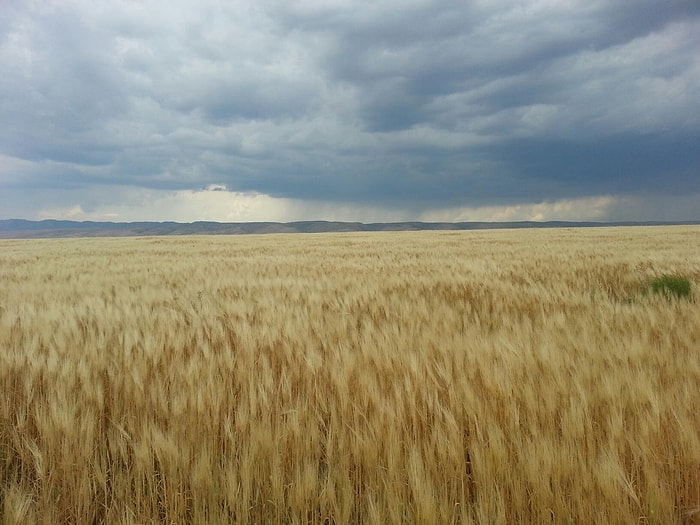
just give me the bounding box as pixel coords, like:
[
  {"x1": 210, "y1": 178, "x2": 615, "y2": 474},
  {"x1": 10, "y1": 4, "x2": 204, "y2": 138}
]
[{"x1": 0, "y1": 0, "x2": 700, "y2": 222}]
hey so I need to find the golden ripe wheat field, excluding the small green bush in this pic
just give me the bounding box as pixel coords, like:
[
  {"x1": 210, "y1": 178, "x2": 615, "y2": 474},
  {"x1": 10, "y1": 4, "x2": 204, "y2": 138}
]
[{"x1": 0, "y1": 226, "x2": 700, "y2": 525}]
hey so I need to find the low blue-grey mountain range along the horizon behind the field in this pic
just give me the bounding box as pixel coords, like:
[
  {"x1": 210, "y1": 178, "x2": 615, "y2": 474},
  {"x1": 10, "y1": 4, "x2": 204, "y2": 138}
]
[{"x1": 0, "y1": 219, "x2": 700, "y2": 239}]
